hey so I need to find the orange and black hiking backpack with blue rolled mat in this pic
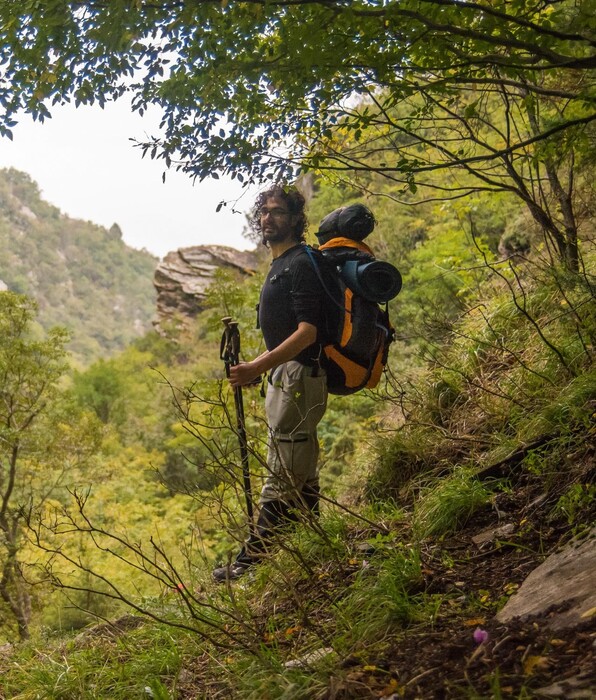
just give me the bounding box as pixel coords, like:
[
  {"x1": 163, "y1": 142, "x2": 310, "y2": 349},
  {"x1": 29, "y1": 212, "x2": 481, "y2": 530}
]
[{"x1": 307, "y1": 205, "x2": 401, "y2": 395}]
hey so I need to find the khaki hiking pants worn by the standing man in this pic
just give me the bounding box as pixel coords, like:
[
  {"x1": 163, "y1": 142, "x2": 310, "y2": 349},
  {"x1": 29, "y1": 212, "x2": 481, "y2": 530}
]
[{"x1": 261, "y1": 360, "x2": 327, "y2": 504}]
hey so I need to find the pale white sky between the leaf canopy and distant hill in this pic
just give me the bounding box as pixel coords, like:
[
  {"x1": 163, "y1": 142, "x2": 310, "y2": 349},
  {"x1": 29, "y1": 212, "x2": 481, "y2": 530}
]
[{"x1": 0, "y1": 100, "x2": 257, "y2": 258}]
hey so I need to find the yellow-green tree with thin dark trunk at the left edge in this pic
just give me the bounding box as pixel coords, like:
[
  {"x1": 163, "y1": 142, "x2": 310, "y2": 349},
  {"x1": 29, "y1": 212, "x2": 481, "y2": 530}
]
[{"x1": 0, "y1": 292, "x2": 98, "y2": 639}]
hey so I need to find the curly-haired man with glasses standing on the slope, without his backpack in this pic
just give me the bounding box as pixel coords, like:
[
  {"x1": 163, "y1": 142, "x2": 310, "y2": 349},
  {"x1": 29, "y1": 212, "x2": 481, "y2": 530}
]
[{"x1": 213, "y1": 186, "x2": 327, "y2": 582}]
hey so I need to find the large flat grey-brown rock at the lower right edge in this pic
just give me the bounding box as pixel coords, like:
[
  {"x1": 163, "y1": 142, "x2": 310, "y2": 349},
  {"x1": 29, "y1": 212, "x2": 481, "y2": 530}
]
[{"x1": 497, "y1": 528, "x2": 596, "y2": 630}]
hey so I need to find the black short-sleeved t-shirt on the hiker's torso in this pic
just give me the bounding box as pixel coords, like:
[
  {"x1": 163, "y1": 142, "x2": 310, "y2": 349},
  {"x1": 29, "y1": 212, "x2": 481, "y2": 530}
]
[{"x1": 259, "y1": 244, "x2": 324, "y2": 366}]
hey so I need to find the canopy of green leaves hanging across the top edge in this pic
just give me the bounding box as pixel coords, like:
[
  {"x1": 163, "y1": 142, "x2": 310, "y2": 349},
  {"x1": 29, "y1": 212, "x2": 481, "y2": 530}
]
[{"x1": 0, "y1": 0, "x2": 596, "y2": 178}]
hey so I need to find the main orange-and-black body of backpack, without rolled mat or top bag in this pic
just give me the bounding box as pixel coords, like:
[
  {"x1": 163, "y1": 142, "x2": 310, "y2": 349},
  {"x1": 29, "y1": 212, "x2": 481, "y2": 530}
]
[{"x1": 307, "y1": 242, "x2": 399, "y2": 396}]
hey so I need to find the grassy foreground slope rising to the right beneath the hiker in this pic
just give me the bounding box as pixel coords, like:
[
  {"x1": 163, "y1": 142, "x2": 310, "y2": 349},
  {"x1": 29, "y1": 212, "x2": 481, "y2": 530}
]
[{"x1": 0, "y1": 260, "x2": 596, "y2": 700}]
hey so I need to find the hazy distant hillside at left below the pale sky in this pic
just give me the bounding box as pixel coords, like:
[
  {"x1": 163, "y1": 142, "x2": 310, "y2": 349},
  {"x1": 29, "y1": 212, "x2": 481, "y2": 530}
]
[{"x1": 0, "y1": 170, "x2": 157, "y2": 363}]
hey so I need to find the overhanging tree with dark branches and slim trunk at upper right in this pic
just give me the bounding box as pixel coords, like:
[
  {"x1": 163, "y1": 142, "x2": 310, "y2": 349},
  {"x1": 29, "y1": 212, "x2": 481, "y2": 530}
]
[{"x1": 0, "y1": 0, "x2": 596, "y2": 270}]
